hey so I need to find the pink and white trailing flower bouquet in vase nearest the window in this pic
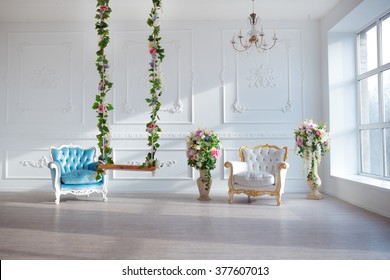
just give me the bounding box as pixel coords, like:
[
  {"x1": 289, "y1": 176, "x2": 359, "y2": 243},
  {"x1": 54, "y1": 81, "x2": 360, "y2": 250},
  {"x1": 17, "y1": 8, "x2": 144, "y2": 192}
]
[{"x1": 294, "y1": 119, "x2": 329, "y2": 189}]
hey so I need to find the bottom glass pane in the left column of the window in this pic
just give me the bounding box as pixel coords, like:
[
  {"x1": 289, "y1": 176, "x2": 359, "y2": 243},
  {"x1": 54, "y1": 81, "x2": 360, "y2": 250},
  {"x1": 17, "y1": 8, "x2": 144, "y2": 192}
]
[{"x1": 361, "y1": 129, "x2": 382, "y2": 176}]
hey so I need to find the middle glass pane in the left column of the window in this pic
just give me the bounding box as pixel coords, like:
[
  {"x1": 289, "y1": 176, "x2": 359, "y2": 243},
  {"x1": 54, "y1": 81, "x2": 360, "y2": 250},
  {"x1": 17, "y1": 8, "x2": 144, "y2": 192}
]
[{"x1": 360, "y1": 75, "x2": 379, "y2": 124}]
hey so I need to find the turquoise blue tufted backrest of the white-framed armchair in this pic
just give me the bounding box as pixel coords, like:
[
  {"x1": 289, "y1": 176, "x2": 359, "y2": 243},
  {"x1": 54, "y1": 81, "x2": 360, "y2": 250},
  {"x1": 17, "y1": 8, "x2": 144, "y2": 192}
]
[{"x1": 50, "y1": 146, "x2": 96, "y2": 174}]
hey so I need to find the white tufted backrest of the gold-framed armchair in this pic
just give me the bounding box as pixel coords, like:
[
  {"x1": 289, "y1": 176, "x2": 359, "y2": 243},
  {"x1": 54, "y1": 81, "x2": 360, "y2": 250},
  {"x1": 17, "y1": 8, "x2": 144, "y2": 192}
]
[{"x1": 240, "y1": 145, "x2": 287, "y2": 175}]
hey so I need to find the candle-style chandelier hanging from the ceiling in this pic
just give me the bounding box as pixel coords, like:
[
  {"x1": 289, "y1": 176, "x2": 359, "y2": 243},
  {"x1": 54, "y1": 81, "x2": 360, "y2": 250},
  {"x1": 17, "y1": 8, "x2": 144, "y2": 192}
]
[{"x1": 231, "y1": 0, "x2": 278, "y2": 52}]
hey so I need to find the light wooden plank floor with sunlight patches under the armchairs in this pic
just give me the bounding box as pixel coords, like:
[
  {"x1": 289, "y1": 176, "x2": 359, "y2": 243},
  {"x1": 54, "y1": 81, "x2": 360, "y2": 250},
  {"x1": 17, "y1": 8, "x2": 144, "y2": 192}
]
[{"x1": 0, "y1": 192, "x2": 390, "y2": 260}]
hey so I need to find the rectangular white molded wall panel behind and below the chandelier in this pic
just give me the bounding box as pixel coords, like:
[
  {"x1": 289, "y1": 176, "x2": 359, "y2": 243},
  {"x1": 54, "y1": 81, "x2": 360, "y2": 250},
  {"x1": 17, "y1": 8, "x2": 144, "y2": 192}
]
[{"x1": 220, "y1": 30, "x2": 303, "y2": 124}]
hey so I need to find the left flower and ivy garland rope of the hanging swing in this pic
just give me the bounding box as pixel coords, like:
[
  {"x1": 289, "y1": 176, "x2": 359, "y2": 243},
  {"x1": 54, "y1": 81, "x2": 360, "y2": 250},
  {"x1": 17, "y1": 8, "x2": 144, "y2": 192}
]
[{"x1": 92, "y1": 0, "x2": 113, "y2": 180}]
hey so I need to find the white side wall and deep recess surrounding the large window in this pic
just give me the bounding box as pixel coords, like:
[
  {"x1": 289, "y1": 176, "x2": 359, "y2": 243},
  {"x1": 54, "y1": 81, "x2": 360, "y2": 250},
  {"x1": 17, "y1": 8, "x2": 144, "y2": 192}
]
[{"x1": 321, "y1": 0, "x2": 390, "y2": 217}]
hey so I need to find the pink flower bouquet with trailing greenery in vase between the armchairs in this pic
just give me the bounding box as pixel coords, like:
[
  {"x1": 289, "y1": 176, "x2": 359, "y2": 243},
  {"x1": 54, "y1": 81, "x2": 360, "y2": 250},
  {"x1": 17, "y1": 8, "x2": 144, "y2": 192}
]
[{"x1": 187, "y1": 129, "x2": 221, "y2": 191}]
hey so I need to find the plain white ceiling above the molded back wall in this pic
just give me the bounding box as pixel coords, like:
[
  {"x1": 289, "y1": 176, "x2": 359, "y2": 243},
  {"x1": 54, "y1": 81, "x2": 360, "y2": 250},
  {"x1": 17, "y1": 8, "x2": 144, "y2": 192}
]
[{"x1": 0, "y1": 0, "x2": 343, "y2": 22}]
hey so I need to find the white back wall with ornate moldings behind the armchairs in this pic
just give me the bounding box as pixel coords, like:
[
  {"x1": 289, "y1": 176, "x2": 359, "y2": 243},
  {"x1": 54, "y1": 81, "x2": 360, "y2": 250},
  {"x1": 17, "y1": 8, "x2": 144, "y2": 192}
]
[{"x1": 0, "y1": 17, "x2": 326, "y2": 197}]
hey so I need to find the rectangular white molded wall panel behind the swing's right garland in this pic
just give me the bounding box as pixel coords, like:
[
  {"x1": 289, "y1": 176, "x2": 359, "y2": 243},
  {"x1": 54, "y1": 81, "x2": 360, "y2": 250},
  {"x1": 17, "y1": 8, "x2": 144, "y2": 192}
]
[{"x1": 113, "y1": 30, "x2": 194, "y2": 125}]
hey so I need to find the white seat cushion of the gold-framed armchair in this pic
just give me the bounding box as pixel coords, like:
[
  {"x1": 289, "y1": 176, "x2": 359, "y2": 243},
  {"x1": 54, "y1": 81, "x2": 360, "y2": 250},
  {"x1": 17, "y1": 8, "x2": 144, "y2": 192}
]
[{"x1": 233, "y1": 171, "x2": 275, "y2": 187}]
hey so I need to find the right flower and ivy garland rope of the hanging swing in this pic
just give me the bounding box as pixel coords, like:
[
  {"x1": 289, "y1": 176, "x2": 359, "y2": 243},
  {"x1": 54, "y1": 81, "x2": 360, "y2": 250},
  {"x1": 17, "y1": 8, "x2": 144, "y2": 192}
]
[{"x1": 143, "y1": 0, "x2": 165, "y2": 167}]
